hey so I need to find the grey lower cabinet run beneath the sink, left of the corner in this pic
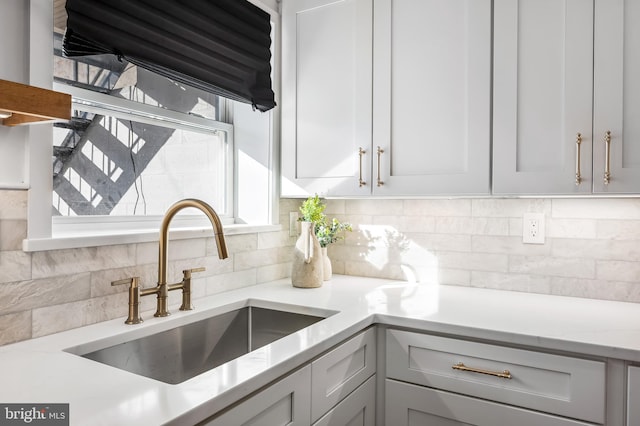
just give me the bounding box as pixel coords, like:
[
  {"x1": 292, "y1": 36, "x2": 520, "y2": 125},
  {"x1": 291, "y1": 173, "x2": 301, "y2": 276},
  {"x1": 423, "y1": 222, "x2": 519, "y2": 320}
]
[{"x1": 201, "y1": 328, "x2": 376, "y2": 426}]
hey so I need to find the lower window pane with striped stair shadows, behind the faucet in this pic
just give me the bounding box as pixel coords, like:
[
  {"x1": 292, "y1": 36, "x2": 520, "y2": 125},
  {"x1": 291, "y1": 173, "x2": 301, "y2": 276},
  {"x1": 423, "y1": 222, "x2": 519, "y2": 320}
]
[{"x1": 53, "y1": 111, "x2": 227, "y2": 216}]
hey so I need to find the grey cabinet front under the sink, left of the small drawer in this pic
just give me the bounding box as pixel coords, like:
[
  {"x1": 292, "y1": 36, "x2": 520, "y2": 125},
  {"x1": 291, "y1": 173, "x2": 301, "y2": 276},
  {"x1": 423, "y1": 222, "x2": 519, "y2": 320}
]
[{"x1": 202, "y1": 366, "x2": 311, "y2": 426}]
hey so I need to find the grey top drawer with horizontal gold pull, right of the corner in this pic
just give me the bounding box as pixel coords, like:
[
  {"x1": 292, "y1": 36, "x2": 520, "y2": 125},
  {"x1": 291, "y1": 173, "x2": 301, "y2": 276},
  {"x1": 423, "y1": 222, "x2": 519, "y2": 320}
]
[{"x1": 386, "y1": 330, "x2": 605, "y2": 423}]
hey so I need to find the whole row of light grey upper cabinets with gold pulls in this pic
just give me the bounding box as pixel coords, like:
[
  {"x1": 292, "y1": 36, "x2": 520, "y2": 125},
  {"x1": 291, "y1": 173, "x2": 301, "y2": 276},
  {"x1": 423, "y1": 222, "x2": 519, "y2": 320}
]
[{"x1": 282, "y1": 0, "x2": 640, "y2": 196}]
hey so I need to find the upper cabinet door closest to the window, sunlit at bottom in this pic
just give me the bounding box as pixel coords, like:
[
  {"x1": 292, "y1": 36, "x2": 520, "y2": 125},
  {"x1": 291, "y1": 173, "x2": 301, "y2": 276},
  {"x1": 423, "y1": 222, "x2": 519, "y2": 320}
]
[{"x1": 281, "y1": 0, "x2": 373, "y2": 196}]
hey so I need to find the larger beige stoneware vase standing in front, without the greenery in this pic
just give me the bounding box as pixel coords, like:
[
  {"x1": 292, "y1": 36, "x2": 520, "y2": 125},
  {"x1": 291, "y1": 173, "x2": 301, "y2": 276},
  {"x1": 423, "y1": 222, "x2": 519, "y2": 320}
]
[{"x1": 291, "y1": 222, "x2": 323, "y2": 288}]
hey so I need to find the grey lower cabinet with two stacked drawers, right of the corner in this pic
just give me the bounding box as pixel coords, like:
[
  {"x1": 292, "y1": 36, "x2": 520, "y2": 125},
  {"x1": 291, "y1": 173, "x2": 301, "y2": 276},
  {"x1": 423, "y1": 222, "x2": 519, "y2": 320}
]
[{"x1": 386, "y1": 330, "x2": 606, "y2": 425}]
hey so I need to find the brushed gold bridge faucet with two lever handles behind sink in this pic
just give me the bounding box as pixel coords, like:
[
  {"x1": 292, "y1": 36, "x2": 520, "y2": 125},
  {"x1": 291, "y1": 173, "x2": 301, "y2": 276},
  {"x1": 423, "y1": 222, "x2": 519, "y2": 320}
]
[{"x1": 111, "y1": 198, "x2": 228, "y2": 324}]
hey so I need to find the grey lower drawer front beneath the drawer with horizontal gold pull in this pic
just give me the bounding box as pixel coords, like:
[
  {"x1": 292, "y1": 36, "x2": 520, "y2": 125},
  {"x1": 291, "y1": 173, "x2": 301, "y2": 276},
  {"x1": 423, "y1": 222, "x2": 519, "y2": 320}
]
[{"x1": 385, "y1": 379, "x2": 592, "y2": 426}]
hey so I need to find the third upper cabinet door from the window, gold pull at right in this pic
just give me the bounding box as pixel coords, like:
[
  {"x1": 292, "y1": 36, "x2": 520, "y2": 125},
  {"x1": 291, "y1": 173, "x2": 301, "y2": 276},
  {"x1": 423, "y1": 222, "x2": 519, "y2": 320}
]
[{"x1": 493, "y1": 0, "x2": 593, "y2": 194}]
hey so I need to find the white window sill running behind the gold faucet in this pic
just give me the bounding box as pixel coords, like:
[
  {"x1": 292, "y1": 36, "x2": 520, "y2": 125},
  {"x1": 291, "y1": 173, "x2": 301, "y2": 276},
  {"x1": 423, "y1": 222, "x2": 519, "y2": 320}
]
[{"x1": 22, "y1": 224, "x2": 281, "y2": 252}]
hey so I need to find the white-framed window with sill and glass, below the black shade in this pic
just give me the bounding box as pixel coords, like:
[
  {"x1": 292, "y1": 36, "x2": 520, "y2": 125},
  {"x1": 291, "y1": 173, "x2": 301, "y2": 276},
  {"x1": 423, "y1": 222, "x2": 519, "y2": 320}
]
[{"x1": 24, "y1": 0, "x2": 279, "y2": 251}]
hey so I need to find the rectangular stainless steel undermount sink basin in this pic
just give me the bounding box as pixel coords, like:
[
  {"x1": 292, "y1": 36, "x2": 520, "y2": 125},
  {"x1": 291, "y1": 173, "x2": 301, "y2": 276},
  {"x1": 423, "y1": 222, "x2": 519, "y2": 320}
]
[{"x1": 68, "y1": 306, "x2": 325, "y2": 384}]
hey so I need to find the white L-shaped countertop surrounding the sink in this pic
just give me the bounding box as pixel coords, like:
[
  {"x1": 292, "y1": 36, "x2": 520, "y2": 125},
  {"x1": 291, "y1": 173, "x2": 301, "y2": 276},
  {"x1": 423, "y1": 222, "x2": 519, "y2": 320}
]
[{"x1": 0, "y1": 276, "x2": 640, "y2": 425}]
